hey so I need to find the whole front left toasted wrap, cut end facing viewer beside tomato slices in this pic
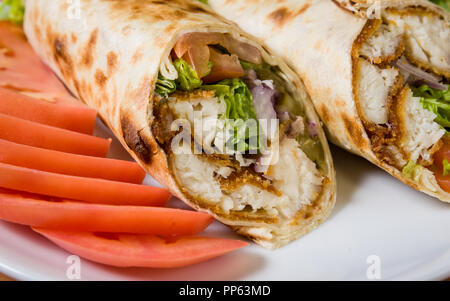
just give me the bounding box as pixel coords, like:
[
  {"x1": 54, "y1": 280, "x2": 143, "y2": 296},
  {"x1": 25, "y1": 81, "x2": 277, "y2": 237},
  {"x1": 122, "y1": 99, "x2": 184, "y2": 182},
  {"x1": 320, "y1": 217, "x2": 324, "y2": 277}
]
[{"x1": 24, "y1": 0, "x2": 336, "y2": 248}]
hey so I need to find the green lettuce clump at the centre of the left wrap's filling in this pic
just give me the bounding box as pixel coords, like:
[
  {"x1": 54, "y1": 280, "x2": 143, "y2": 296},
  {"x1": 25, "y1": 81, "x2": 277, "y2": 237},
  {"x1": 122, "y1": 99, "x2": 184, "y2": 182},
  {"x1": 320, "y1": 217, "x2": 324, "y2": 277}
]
[{"x1": 202, "y1": 78, "x2": 261, "y2": 153}]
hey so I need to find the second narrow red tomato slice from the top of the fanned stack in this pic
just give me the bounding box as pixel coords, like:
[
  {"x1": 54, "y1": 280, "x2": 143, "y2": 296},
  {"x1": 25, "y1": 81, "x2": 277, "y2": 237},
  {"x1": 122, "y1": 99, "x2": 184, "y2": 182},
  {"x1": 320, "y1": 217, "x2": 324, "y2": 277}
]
[{"x1": 0, "y1": 113, "x2": 111, "y2": 157}]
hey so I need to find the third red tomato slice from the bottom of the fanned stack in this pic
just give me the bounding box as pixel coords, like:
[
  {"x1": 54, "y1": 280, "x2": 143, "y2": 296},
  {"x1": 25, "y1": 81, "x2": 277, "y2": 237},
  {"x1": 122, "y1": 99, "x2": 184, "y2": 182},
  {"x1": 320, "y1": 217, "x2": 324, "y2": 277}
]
[{"x1": 0, "y1": 163, "x2": 170, "y2": 206}]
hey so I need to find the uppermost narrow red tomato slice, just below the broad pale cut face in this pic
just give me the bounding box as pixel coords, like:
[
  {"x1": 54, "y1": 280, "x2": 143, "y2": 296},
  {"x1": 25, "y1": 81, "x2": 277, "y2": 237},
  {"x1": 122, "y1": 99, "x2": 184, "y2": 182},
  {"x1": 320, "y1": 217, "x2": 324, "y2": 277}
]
[{"x1": 0, "y1": 88, "x2": 97, "y2": 135}]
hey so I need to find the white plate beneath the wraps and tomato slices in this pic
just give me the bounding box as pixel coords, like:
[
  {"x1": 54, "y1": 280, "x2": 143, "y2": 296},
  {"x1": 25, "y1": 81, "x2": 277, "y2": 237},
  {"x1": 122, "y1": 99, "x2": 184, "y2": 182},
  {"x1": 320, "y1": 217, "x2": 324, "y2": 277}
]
[{"x1": 0, "y1": 118, "x2": 450, "y2": 280}]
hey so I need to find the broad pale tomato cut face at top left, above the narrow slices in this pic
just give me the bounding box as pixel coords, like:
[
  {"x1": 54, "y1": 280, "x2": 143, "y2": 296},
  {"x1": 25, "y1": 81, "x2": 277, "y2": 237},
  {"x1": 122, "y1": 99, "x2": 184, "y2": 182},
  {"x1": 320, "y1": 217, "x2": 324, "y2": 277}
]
[{"x1": 0, "y1": 21, "x2": 81, "y2": 105}]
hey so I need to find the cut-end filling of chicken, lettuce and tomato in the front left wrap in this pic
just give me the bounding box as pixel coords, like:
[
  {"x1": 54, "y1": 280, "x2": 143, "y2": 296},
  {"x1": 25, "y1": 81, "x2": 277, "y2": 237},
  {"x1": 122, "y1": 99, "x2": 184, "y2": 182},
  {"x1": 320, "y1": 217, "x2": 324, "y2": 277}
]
[{"x1": 151, "y1": 32, "x2": 326, "y2": 218}]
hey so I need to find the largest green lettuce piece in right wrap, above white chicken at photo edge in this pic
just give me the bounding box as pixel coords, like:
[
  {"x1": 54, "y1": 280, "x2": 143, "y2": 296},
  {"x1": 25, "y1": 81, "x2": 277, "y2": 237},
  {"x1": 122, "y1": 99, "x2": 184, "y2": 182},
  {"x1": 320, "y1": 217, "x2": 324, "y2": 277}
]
[{"x1": 412, "y1": 84, "x2": 450, "y2": 128}]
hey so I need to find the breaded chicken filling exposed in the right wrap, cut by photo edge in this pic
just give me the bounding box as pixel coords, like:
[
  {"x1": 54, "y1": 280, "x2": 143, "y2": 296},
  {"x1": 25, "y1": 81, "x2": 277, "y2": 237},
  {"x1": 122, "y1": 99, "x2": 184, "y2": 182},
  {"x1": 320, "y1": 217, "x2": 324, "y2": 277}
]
[{"x1": 353, "y1": 8, "x2": 450, "y2": 192}]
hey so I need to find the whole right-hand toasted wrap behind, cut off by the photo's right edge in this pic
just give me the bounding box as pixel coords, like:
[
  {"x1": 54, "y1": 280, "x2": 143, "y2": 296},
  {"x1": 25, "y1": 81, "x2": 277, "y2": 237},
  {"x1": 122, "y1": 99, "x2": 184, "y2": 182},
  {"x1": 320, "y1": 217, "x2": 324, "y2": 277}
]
[{"x1": 209, "y1": 0, "x2": 450, "y2": 202}]
